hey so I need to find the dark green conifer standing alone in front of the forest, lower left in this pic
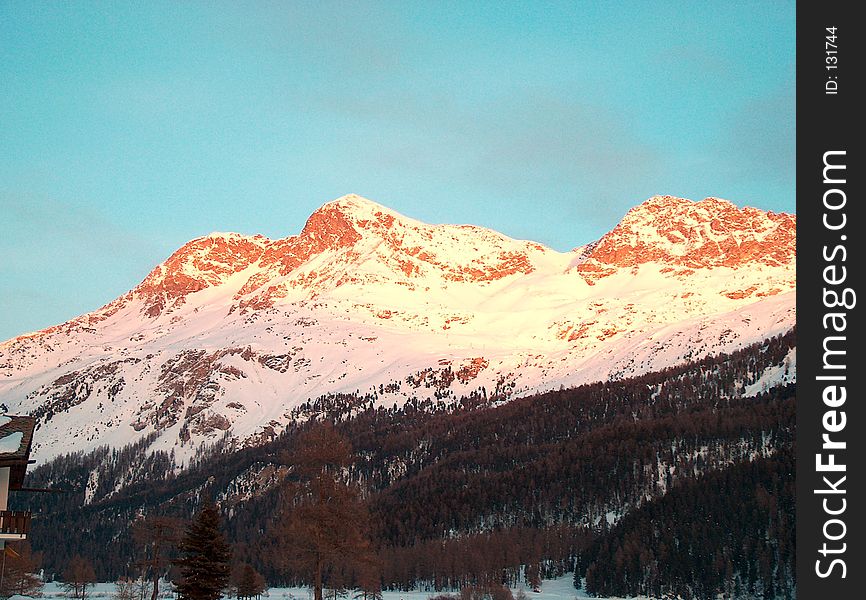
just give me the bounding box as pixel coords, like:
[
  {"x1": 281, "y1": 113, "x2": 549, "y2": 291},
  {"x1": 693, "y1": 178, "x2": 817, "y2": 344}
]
[{"x1": 174, "y1": 504, "x2": 231, "y2": 600}]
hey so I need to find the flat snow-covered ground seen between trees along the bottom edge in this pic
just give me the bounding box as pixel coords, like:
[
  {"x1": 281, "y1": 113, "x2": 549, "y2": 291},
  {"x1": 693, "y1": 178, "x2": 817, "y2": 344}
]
[{"x1": 37, "y1": 573, "x2": 649, "y2": 600}]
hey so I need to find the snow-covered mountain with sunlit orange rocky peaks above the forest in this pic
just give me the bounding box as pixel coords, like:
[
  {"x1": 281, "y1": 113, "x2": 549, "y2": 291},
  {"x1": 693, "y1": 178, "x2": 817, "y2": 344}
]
[{"x1": 0, "y1": 195, "x2": 796, "y2": 460}]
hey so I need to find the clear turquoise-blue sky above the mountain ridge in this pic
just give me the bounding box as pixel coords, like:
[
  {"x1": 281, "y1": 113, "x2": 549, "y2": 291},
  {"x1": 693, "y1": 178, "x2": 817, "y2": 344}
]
[{"x1": 0, "y1": 0, "x2": 795, "y2": 340}]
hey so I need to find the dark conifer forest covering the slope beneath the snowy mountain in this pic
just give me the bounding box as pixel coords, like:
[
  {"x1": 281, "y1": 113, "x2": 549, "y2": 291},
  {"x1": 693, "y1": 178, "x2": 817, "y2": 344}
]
[{"x1": 13, "y1": 332, "x2": 795, "y2": 599}]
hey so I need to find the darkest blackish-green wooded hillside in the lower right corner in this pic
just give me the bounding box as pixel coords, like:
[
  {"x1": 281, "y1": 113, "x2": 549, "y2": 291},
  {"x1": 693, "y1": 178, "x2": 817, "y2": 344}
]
[{"x1": 575, "y1": 448, "x2": 795, "y2": 600}]
